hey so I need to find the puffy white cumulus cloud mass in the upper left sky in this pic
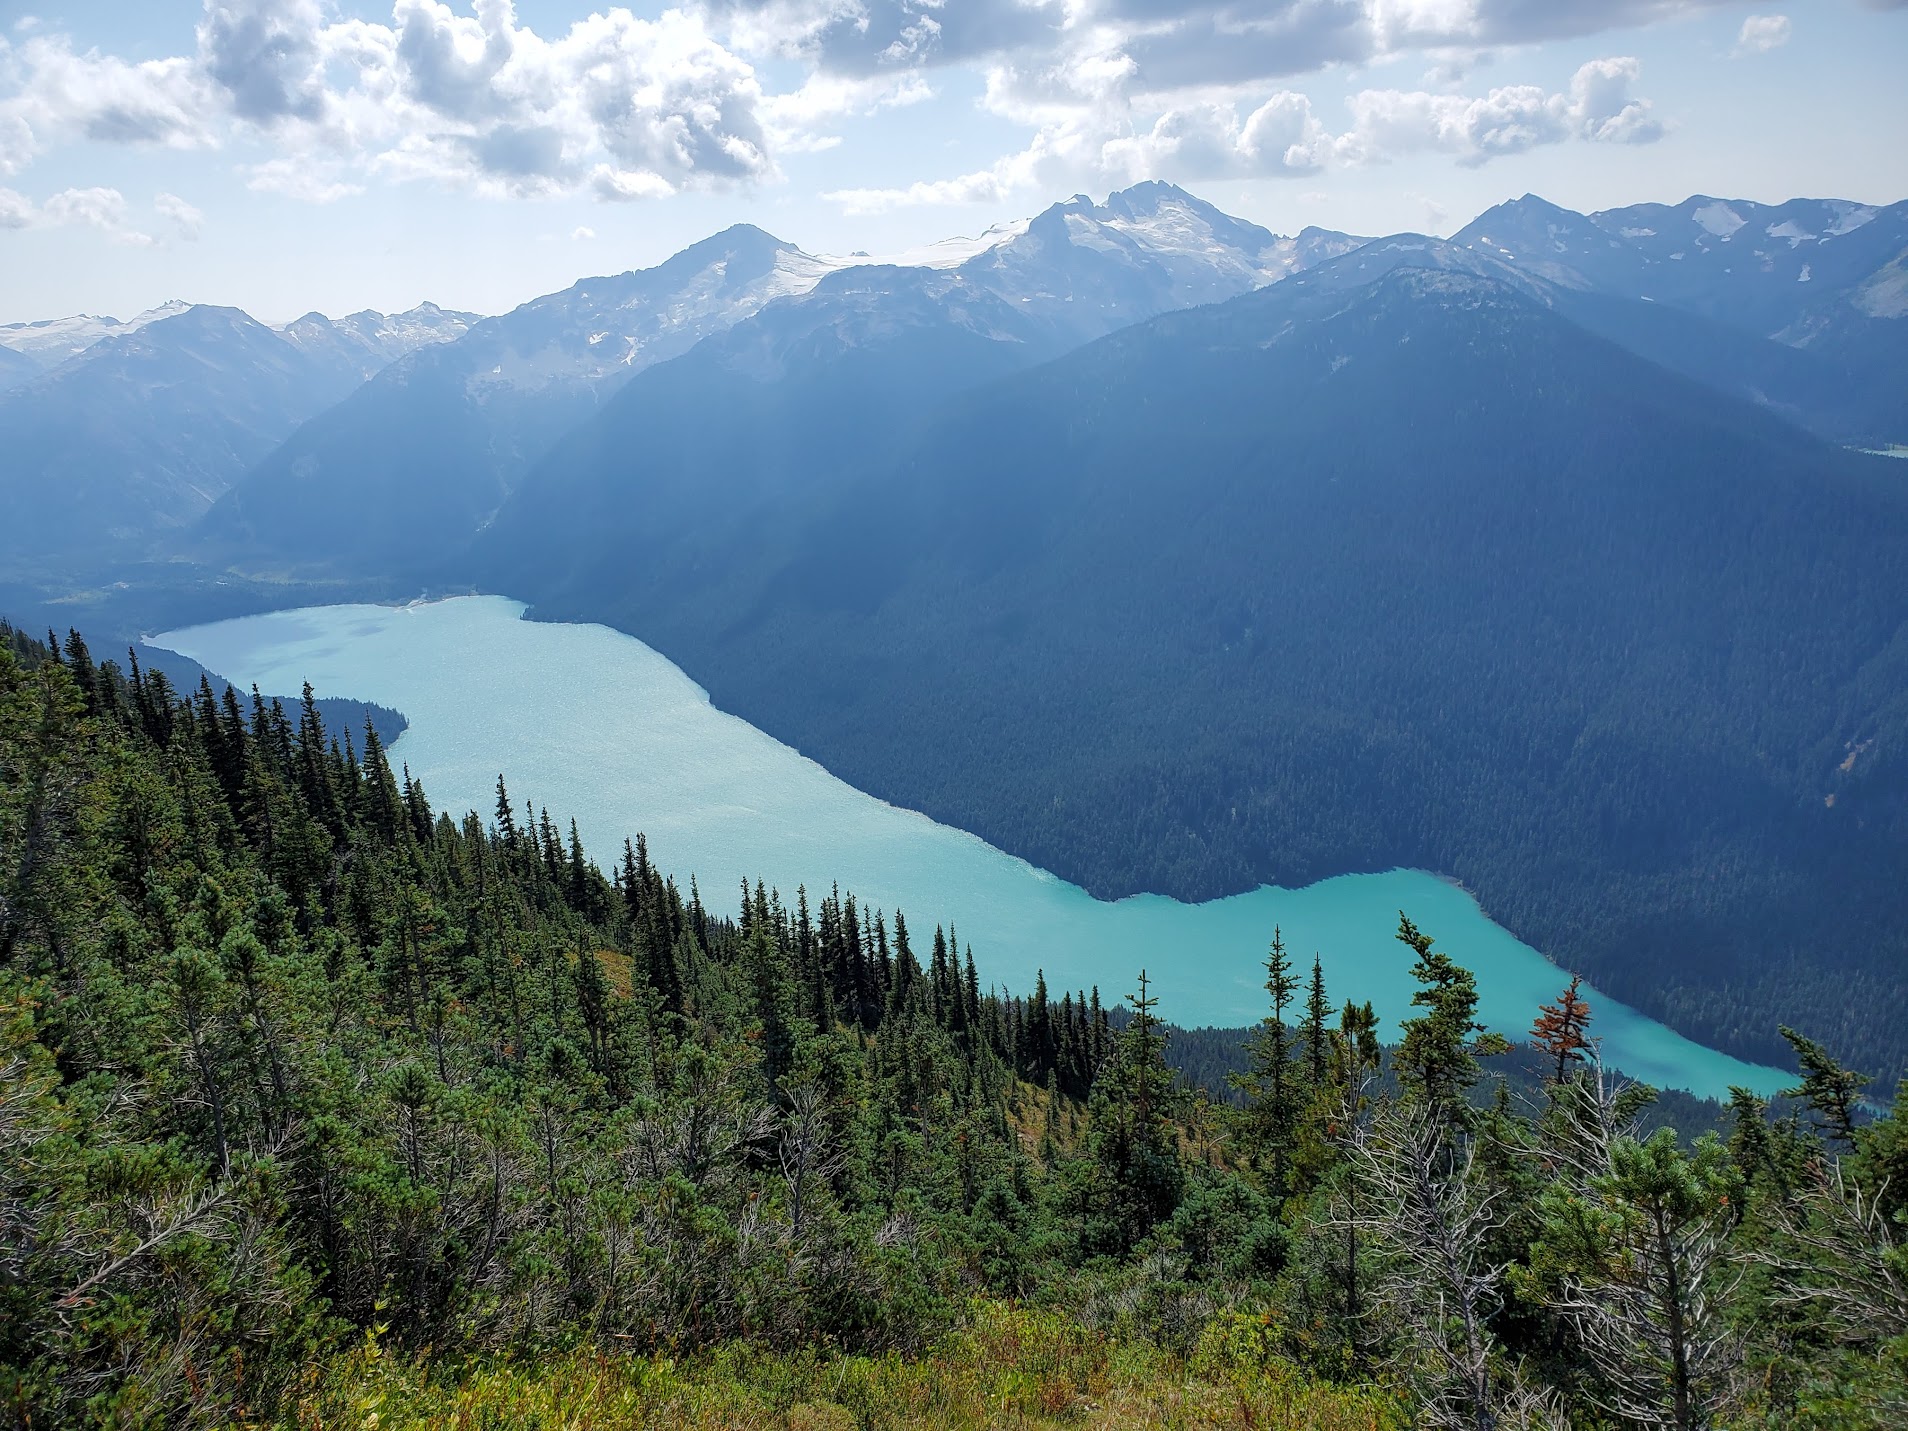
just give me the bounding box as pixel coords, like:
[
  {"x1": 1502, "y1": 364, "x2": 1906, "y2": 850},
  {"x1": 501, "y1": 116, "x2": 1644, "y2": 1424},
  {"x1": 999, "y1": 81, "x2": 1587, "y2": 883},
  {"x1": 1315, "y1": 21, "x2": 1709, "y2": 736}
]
[{"x1": 0, "y1": 0, "x2": 782, "y2": 202}]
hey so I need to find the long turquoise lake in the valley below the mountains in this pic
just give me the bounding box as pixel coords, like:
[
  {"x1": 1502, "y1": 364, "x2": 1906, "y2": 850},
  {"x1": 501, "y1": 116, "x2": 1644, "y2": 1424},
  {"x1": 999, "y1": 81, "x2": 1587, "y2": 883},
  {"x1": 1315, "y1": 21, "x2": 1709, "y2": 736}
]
[{"x1": 147, "y1": 597, "x2": 1792, "y2": 1097}]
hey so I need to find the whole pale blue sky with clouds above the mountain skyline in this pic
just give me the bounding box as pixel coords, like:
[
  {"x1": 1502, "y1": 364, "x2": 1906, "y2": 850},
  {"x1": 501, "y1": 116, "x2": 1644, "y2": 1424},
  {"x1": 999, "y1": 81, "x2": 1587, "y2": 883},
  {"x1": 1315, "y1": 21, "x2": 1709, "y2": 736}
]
[{"x1": 0, "y1": 0, "x2": 1908, "y2": 321}]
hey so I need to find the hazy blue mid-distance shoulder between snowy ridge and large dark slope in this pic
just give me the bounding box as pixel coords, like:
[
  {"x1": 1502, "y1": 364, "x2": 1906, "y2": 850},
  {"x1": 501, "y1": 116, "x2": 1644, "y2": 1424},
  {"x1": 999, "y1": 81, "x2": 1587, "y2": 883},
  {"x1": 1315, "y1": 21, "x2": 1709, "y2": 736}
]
[{"x1": 469, "y1": 267, "x2": 1114, "y2": 591}]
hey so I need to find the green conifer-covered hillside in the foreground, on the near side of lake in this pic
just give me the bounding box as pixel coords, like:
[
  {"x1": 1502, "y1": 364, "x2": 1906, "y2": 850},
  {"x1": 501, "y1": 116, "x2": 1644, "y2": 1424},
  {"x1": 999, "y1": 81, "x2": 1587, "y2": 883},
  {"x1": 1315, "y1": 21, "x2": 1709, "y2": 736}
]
[{"x1": 0, "y1": 624, "x2": 1908, "y2": 1431}]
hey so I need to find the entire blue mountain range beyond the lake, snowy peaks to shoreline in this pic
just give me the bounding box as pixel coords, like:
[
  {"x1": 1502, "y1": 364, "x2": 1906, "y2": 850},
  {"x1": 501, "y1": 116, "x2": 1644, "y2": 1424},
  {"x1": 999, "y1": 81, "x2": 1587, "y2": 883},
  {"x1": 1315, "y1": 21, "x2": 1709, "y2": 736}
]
[{"x1": 0, "y1": 185, "x2": 1908, "y2": 1070}]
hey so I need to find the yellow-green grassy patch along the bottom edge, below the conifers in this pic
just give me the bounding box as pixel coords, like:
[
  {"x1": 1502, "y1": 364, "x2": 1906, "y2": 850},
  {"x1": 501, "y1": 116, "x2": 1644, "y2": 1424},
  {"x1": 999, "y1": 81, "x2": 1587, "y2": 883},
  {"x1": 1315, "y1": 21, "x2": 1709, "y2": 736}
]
[{"x1": 280, "y1": 1305, "x2": 1406, "y2": 1431}]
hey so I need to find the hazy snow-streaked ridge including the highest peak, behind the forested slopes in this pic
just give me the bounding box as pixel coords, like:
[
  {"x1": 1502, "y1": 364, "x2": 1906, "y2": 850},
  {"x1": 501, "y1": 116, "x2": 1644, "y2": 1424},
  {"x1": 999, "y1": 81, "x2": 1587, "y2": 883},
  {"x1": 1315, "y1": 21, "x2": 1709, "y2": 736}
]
[{"x1": 206, "y1": 185, "x2": 1360, "y2": 572}]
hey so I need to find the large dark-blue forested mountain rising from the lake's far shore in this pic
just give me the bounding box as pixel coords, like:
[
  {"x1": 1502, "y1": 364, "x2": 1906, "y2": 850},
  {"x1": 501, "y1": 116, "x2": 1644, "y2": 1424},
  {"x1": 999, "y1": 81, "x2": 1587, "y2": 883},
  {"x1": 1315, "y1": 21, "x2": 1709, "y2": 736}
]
[{"x1": 479, "y1": 259, "x2": 1908, "y2": 1068}]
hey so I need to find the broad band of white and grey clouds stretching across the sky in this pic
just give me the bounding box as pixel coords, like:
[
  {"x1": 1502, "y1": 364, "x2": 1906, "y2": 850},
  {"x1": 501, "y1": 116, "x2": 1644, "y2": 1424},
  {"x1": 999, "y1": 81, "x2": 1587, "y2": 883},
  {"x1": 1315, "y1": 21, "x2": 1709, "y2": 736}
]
[{"x1": 0, "y1": 0, "x2": 1717, "y2": 212}]
